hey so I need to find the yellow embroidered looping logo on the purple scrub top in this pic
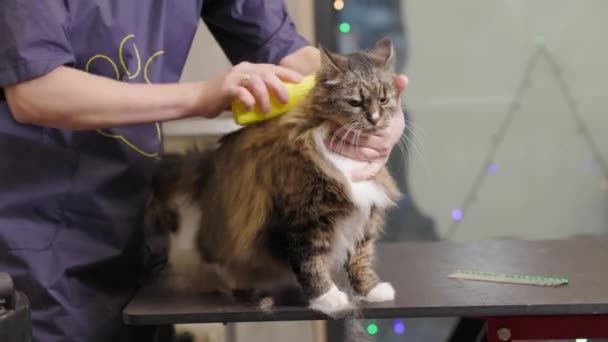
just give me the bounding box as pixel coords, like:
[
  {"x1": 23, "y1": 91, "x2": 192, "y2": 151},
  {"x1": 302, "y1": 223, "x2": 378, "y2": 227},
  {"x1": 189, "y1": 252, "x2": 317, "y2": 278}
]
[{"x1": 85, "y1": 34, "x2": 165, "y2": 158}]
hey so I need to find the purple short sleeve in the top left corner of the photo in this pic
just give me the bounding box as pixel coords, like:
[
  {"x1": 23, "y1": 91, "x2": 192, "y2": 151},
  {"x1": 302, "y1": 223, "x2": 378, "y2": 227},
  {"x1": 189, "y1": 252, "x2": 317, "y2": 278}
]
[{"x1": 0, "y1": 0, "x2": 75, "y2": 87}]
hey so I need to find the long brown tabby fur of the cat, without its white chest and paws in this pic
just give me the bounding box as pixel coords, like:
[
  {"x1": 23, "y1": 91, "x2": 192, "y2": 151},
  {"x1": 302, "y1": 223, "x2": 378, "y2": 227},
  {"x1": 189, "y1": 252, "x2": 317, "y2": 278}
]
[{"x1": 146, "y1": 39, "x2": 400, "y2": 316}]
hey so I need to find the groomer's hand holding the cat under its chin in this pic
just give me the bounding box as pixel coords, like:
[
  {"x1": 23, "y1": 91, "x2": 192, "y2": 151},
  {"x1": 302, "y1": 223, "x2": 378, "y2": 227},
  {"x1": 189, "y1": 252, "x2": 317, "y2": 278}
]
[{"x1": 326, "y1": 75, "x2": 408, "y2": 182}]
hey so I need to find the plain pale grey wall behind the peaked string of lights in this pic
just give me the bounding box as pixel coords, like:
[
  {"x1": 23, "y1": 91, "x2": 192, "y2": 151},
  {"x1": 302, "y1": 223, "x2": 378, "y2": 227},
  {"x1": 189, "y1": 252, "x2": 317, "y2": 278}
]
[{"x1": 405, "y1": 0, "x2": 608, "y2": 239}]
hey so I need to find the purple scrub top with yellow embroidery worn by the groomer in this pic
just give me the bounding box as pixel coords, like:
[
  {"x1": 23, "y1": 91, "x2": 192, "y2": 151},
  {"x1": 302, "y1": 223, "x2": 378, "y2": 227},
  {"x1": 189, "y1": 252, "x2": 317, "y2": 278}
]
[{"x1": 0, "y1": 0, "x2": 308, "y2": 342}]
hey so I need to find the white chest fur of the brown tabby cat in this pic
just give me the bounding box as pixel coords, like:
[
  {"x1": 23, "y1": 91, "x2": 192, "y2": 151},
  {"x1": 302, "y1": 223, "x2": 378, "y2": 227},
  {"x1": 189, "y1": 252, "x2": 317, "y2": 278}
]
[{"x1": 315, "y1": 127, "x2": 391, "y2": 269}]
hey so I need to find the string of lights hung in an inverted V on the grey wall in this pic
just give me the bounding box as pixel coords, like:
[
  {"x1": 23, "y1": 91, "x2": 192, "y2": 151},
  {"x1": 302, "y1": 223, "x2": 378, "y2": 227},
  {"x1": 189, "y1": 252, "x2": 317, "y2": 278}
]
[{"x1": 445, "y1": 42, "x2": 608, "y2": 239}]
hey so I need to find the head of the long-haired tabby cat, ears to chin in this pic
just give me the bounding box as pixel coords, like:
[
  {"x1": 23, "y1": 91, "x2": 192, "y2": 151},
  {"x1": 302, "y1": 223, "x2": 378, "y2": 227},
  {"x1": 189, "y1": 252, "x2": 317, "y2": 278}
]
[{"x1": 311, "y1": 38, "x2": 400, "y2": 133}]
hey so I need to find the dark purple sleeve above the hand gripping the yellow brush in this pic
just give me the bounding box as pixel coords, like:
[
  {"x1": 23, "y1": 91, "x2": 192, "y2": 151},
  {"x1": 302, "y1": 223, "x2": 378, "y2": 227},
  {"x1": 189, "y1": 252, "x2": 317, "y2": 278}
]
[{"x1": 201, "y1": 0, "x2": 310, "y2": 64}]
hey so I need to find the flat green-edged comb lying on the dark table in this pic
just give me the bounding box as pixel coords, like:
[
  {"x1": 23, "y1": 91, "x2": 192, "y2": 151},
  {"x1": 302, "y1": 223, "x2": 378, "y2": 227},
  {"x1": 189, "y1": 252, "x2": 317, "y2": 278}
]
[{"x1": 448, "y1": 270, "x2": 568, "y2": 286}]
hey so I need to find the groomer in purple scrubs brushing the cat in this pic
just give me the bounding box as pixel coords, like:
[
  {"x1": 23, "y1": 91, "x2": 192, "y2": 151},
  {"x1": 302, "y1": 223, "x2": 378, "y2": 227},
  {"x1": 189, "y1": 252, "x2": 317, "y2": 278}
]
[{"x1": 0, "y1": 0, "x2": 407, "y2": 342}]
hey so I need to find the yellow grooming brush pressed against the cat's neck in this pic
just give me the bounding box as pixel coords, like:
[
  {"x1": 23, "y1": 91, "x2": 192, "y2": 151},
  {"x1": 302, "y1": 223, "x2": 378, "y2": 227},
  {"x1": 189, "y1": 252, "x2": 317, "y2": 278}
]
[{"x1": 232, "y1": 75, "x2": 315, "y2": 126}]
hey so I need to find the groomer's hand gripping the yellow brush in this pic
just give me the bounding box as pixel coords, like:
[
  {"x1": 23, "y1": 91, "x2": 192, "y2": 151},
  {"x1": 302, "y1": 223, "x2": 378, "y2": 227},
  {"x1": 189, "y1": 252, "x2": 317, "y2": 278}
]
[{"x1": 200, "y1": 62, "x2": 303, "y2": 117}]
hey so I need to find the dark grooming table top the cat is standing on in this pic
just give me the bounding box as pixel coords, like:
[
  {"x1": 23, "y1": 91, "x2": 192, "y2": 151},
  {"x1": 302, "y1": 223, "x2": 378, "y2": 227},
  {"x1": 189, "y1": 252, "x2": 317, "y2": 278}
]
[{"x1": 123, "y1": 239, "x2": 608, "y2": 325}]
